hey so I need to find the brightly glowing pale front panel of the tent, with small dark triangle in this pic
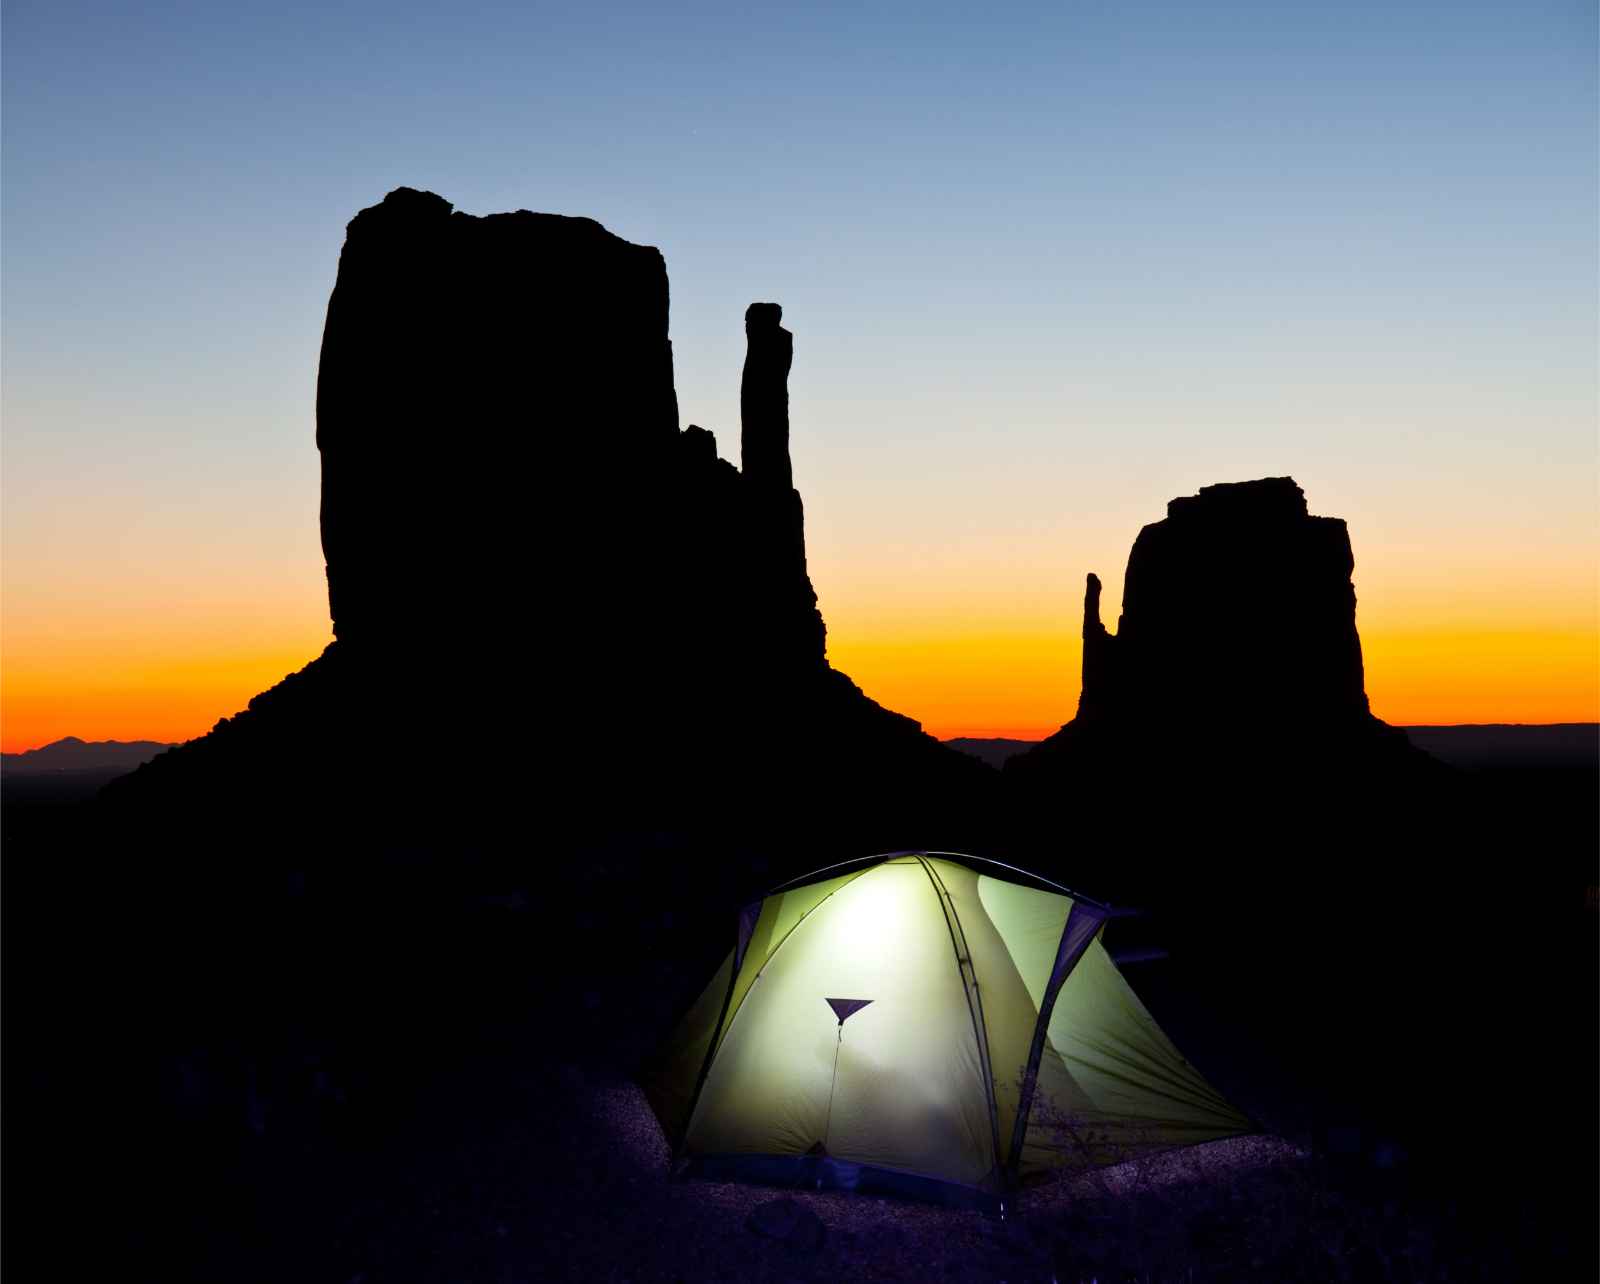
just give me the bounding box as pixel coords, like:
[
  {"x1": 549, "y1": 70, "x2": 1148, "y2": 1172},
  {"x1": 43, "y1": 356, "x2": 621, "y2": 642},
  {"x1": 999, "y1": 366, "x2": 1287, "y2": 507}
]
[{"x1": 688, "y1": 860, "x2": 994, "y2": 1183}]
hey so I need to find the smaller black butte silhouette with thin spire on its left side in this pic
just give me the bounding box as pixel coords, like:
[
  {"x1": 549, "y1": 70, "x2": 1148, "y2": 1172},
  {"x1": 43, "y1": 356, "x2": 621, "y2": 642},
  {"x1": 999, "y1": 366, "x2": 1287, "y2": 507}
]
[{"x1": 1008, "y1": 477, "x2": 1430, "y2": 799}]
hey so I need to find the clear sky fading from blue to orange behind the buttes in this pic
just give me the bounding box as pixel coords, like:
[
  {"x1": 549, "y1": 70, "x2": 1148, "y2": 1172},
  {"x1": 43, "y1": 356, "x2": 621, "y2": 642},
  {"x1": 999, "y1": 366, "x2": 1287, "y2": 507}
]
[{"x1": 0, "y1": 0, "x2": 1600, "y2": 749}]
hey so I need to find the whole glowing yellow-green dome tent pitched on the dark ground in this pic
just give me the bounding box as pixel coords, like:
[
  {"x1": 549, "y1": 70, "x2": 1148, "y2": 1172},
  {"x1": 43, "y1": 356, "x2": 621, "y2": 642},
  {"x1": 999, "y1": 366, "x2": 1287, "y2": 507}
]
[{"x1": 645, "y1": 852, "x2": 1254, "y2": 1206}]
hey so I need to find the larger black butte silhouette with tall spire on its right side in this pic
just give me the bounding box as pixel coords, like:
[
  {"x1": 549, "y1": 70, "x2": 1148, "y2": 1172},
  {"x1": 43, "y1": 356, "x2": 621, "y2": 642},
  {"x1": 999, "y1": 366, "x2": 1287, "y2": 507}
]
[{"x1": 112, "y1": 187, "x2": 987, "y2": 841}]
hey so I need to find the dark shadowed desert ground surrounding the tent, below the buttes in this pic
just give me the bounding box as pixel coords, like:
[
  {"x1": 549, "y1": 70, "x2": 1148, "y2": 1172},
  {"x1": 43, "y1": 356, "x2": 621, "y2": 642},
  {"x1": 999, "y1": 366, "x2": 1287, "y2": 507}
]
[{"x1": 3, "y1": 749, "x2": 1600, "y2": 1284}]
